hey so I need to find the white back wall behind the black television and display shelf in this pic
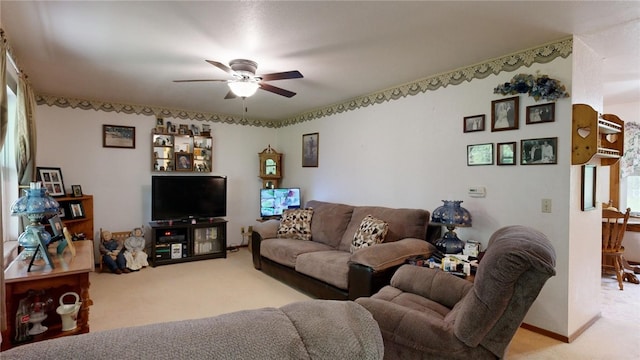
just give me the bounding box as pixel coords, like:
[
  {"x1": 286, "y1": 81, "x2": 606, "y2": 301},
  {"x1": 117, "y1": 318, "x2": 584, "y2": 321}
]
[{"x1": 36, "y1": 105, "x2": 279, "y2": 256}]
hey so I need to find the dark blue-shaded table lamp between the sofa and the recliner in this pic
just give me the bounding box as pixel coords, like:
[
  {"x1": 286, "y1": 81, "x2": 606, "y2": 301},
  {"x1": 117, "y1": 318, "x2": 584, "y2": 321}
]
[{"x1": 431, "y1": 200, "x2": 471, "y2": 254}]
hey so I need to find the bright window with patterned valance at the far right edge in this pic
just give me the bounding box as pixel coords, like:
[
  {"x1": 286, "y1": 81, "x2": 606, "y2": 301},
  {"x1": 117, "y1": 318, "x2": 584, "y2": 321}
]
[{"x1": 620, "y1": 122, "x2": 640, "y2": 215}]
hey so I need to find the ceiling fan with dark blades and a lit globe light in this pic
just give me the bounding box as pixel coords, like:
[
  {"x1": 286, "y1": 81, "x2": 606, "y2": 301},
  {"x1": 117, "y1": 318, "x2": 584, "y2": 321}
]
[{"x1": 173, "y1": 59, "x2": 303, "y2": 99}]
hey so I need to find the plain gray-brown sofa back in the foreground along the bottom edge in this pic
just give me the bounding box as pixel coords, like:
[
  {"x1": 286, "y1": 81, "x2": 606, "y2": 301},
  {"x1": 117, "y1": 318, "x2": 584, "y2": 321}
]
[{"x1": 0, "y1": 300, "x2": 384, "y2": 360}]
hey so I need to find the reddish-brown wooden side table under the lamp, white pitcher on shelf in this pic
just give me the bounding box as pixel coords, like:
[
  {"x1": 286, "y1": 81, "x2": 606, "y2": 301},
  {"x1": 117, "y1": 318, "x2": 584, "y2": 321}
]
[{"x1": 2, "y1": 240, "x2": 94, "y2": 350}]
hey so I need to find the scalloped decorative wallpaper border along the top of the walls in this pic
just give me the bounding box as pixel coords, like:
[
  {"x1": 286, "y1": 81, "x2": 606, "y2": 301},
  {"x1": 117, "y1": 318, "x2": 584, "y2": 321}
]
[{"x1": 36, "y1": 37, "x2": 573, "y2": 128}]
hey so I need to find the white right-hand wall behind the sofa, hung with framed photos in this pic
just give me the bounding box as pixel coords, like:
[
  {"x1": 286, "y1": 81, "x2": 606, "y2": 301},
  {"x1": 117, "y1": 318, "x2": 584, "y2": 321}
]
[{"x1": 278, "y1": 58, "x2": 576, "y2": 335}]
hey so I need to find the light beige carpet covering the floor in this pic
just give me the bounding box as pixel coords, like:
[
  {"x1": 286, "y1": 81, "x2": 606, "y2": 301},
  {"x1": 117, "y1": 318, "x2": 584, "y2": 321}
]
[{"x1": 89, "y1": 248, "x2": 640, "y2": 360}]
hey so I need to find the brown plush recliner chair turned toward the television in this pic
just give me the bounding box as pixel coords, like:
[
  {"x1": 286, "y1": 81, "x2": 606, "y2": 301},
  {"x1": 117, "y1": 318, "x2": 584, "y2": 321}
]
[{"x1": 356, "y1": 226, "x2": 555, "y2": 360}]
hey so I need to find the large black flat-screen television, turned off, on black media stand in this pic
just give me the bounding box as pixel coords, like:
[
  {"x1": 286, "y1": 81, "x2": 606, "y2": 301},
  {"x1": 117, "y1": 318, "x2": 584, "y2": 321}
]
[{"x1": 151, "y1": 175, "x2": 227, "y2": 221}]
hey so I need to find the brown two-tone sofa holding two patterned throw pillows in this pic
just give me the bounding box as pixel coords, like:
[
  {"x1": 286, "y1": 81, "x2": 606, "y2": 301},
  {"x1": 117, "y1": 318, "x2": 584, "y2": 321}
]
[{"x1": 251, "y1": 200, "x2": 440, "y2": 300}]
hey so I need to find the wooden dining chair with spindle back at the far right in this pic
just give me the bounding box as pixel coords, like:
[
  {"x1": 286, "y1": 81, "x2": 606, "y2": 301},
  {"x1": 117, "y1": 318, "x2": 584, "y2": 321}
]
[{"x1": 602, "y1": 209, "x2": 631, "y2": 290}]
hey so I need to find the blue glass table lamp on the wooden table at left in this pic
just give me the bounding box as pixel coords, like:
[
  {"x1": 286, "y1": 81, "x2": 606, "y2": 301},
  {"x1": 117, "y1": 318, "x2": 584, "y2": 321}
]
[{"x1": 11, "y1": 182, "x2": 60, "y2": 260}]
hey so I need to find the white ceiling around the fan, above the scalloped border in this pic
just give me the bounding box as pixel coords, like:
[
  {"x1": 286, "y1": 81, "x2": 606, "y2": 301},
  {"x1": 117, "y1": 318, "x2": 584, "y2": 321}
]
[{"x1": 0, "y1": 0, "x2": 640, "y2": 119}]
